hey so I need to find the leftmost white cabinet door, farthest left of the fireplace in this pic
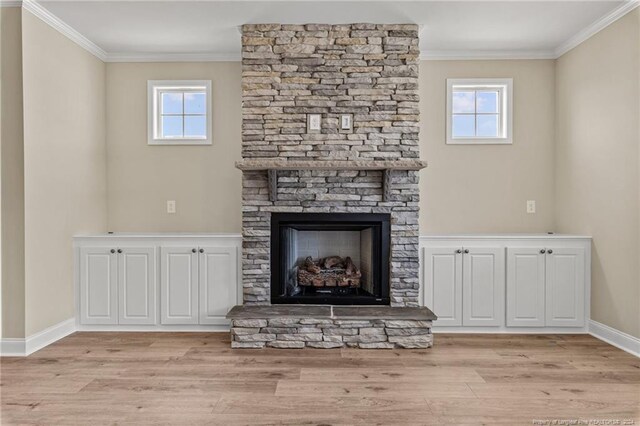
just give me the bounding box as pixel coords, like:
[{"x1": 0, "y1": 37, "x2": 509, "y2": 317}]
[{"x1": 80, "y1": 247, "x2": 118, "y2": 324}]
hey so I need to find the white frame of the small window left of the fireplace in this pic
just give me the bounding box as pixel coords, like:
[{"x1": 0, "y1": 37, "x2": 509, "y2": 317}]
[{"x1": 147, "y1": 80, "x2": 213, "y2": 145}]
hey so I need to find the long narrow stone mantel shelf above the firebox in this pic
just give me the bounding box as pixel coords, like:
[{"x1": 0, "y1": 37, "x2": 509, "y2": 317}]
[{"x1": 236, "y1": 160, "x2": 427, "y2": 170}]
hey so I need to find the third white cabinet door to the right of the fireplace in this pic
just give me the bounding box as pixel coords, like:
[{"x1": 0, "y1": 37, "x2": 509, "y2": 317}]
[{"x1": 507, "y1": 247, "x2": 545, "y2": 327}]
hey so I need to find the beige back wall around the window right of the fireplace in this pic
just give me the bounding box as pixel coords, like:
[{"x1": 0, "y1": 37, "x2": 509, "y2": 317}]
[{"x1": 420, "y1": 60, "x2": 554, "y2": 235}]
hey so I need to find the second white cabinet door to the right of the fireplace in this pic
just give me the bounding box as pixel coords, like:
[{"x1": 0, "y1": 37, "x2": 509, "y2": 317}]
[{"x1": 462, "y1": 247, "x2": 505, "y2": 326}]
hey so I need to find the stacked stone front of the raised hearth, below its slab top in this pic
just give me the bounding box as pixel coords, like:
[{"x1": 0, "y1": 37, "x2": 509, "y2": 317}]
[{"x1": 231, "y1": 318, "x2": 433, "y2": 349}]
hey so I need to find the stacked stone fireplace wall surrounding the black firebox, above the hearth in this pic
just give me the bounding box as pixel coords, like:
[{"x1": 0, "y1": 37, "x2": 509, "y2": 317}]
[{"x1": 242, "y1": 24, "x2": 419, "y2": 306}]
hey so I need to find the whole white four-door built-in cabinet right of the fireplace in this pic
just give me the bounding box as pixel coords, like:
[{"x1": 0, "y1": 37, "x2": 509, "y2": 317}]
[{"x1": 420, "y1": 235, "x2": 591, "y2": 331}]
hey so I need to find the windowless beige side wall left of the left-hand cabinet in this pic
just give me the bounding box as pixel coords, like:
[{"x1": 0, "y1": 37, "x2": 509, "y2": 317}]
[{"x1": 22, "y1": 11, "x2": 107, "y2": 336}]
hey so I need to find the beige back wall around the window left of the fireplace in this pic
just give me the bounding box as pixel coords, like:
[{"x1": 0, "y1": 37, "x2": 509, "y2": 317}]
[{"x1": 107, "y1": 62, "x2": 241, "y2": 232}]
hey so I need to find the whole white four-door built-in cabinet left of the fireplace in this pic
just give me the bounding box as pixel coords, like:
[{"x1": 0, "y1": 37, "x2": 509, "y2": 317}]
[{"x1": 74, "y1": 234, "x2": 242, "y2": 329}]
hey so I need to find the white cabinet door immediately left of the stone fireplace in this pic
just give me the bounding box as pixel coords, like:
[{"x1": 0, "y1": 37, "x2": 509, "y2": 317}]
[{"x1": 198, "y1": 247, "x2": 238, "y2": 324}]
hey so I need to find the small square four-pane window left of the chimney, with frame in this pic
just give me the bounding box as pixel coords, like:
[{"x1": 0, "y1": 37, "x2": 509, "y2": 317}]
[{"x1": 147, "y1": 80, "x2": 211, "y2": 145}]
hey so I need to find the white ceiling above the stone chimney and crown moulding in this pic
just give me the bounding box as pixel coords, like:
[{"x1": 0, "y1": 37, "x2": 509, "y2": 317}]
[{"x1": 31, "y1": 0, "x2": 628, "y2": 60}]
